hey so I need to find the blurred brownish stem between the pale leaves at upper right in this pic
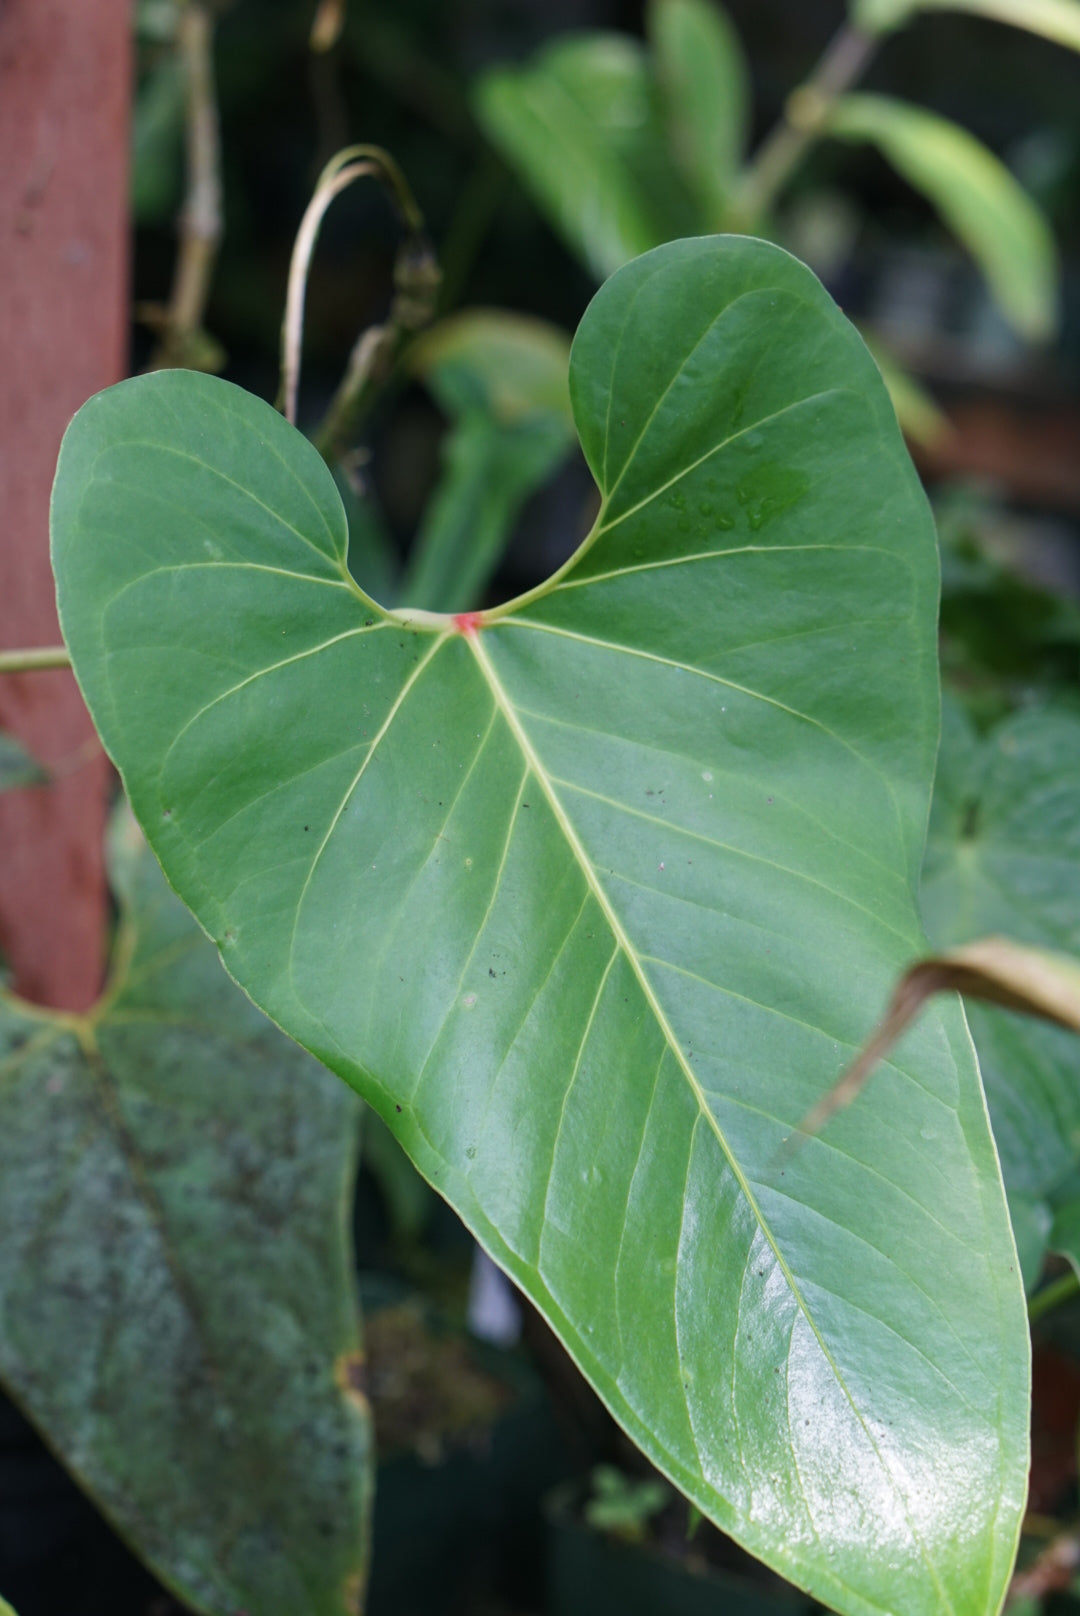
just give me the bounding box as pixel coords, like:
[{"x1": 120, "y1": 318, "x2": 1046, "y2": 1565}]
[{"x1": 736, "y1": 23, "x2": 881, "y2": 229}]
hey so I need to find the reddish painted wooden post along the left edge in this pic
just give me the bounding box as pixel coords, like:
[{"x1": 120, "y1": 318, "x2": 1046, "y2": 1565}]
[{"x1": 0, "y1": 0, "x2": 131, "y2": 1008}]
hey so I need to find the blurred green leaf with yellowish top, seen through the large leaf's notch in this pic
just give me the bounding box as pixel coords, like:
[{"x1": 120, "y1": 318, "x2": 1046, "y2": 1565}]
[{"x1": 399, "y1": 310, "x2": 574, "y2": 611}]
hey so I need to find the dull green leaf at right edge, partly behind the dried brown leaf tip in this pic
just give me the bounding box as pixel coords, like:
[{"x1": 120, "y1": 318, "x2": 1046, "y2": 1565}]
[{"x1": 922, "y1": 703, "x2": 1080, "y2": 1280}]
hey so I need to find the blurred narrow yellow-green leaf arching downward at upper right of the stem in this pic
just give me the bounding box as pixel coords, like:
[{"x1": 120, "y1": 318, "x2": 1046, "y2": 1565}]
[{"x1": 829, "y1": 95, "x2": 1057, "y2": 341}]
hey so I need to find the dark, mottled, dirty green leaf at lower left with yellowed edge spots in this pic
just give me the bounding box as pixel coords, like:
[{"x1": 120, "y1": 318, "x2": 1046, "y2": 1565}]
[{"x1": 0, "y1": 816, "x2": 372, "y2": 1616}]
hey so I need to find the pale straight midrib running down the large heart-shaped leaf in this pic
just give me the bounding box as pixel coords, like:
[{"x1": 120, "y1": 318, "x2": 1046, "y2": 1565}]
[{"x1": 466, "y1": 630, "x2": 956, "y2": 1613}]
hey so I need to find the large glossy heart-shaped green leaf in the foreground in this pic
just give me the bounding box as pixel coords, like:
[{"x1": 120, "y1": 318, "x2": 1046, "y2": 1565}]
[{"x1": 53, "y1": 238, "x2": 1028, "y2": 1616}]
